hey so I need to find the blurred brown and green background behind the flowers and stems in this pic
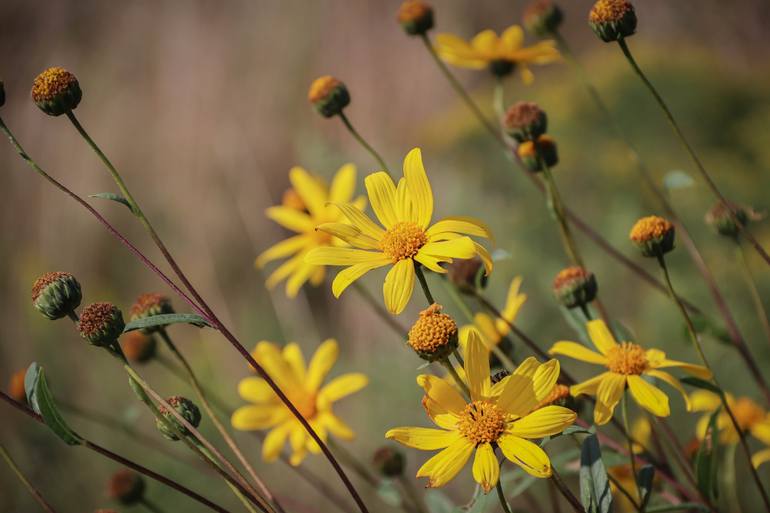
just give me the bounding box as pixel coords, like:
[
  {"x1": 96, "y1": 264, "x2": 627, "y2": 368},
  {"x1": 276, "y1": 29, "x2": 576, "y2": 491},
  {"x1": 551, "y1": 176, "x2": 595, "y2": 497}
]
[{"x1": 0, "y1": 0, "x2": 770, "y2": 512}]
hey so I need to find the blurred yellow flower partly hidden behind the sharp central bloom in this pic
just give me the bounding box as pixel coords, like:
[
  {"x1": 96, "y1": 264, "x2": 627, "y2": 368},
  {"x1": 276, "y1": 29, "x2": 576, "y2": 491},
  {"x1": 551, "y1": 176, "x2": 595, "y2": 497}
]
[{"x1": 255, "y1": 164, "x2": 366, "y2": 297}]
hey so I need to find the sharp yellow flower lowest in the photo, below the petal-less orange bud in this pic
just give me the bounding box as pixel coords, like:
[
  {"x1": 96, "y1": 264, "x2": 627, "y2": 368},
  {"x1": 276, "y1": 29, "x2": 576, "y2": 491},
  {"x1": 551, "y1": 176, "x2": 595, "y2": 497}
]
[{"x1": 385, "y1": 330, "x2": 576, "y2": 492}]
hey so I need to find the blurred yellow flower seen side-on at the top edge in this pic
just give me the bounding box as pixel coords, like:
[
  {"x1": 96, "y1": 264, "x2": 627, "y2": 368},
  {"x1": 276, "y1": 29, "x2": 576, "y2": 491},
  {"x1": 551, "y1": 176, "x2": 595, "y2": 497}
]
[{"x1": 436, "y1": 25, "x2": 559, "y2": 84}]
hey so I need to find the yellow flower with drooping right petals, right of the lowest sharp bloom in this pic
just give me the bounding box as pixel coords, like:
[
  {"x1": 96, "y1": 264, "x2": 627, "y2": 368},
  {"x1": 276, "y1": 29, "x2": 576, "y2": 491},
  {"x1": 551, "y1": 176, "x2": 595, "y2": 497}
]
[{"x1": 549, "y1": 320, "x2": 711, "y2": 425}]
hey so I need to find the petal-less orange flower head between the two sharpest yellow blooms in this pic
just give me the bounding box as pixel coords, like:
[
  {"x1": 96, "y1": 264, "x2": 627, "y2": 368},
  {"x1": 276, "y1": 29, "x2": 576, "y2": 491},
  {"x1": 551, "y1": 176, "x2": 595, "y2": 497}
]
[{"x1": 407, "y1": 303, "x2": 457, "y2": 362}]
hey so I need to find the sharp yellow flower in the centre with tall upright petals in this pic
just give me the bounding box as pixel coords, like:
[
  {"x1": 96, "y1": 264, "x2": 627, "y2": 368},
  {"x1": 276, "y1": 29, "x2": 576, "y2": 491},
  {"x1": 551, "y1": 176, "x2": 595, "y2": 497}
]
[{"x1": 305, "y1": 148, "x2": 492, "y2": 314}]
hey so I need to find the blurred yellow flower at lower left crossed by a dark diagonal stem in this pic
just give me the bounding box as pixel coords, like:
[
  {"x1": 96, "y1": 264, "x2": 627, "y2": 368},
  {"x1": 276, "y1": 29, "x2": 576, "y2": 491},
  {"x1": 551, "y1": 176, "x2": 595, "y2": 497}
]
[{"x1": 230, "y1": 339, "x2": 369, "y2": 465}]
